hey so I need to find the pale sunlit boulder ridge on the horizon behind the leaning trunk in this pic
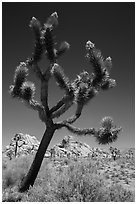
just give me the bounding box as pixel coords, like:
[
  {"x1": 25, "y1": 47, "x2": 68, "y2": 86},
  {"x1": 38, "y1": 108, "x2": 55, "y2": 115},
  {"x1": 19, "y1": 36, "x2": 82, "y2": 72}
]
[{"x1": 3, "y1": 133, "x2": 134, "y2": 159}]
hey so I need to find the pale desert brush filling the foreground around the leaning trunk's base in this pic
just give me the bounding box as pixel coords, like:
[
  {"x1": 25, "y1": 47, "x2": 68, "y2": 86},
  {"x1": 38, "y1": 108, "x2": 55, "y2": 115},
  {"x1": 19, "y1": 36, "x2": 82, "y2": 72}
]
[{"x1": 3, "y1": 157, "x2": 134, "y2": 202}]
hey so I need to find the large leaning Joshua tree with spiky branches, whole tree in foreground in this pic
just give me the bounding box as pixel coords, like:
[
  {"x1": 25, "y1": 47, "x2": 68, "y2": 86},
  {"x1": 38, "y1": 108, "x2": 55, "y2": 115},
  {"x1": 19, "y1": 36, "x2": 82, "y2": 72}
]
[{"x1": 10, "y1": 12, "x2": 121, "y2": 192}]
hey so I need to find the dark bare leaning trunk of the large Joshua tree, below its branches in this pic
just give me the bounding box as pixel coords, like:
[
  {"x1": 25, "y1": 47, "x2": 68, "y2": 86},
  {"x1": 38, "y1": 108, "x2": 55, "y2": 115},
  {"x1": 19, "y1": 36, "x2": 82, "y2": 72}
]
[{"x1": 19, "y1": 125, "x2": 56, "y2": 192}]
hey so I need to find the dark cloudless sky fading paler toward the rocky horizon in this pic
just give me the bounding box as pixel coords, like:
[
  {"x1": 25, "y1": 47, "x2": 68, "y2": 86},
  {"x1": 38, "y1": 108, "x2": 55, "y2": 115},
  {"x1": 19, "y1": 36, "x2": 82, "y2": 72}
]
[{"x1": 2, "y1": 2, "x2": 135, "y2": 151}]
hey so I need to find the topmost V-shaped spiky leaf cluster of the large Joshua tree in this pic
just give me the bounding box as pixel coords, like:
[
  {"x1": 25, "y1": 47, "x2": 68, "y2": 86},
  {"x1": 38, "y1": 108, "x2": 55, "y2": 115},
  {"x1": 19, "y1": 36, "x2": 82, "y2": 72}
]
[{"x1": 29, "y1": 12, "x2": 69, "y2": 65}]
